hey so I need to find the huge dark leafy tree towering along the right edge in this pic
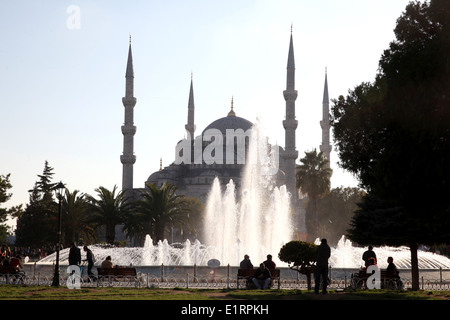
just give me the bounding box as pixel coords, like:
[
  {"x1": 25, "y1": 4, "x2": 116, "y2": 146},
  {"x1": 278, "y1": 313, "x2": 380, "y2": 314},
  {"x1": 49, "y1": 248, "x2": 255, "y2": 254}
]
[{"x1": 331, "y1": 0, "x2": 450, "y2": 290}]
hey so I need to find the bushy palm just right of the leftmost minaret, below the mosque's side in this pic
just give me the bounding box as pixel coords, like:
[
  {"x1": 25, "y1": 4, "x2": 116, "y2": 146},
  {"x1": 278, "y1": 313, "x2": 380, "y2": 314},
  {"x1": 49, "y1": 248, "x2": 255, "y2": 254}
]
[{"x1": 135, "y1": 182, "x2": 190, "y2": 243}]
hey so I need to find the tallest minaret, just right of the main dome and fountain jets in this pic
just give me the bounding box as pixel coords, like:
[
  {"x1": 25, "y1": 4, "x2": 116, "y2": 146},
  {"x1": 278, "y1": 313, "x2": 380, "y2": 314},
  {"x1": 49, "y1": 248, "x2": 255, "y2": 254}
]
[{"x1": 282, "y1": 27, "x2": 298, "y2": 202}]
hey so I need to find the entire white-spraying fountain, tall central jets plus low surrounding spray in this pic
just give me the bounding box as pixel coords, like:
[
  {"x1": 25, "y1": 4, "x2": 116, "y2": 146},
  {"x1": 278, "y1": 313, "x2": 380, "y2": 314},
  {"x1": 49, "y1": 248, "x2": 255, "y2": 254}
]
[{"x1": 38, "y1": 120, "x2": 450, "y2": 269}]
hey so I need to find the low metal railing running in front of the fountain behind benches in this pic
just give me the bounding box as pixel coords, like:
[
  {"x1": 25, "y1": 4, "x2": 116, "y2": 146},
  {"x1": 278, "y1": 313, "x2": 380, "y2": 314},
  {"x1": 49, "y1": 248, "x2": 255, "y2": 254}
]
[{"x1": 0, "y1": 265, "x2": 450, "y2": 291}]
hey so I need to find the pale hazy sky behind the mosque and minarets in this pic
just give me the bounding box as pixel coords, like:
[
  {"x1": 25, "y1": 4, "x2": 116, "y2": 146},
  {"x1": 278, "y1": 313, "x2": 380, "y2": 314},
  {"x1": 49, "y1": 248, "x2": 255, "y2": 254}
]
[{"x1": 0, "y1": 0, "x2": 409, "y2": 228}]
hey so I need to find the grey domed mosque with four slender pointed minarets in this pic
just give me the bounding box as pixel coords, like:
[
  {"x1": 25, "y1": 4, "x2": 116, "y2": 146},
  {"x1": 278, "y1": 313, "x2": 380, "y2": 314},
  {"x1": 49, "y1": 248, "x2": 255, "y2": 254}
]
[{"x1": 120, "y1": 31, "x2": 331, "y2": 212}]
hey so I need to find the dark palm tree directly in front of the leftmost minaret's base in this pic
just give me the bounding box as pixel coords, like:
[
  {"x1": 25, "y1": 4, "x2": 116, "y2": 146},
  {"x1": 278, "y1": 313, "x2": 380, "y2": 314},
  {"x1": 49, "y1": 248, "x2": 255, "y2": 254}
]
[{"x1": 87, "y1": 186, "x2": 131, "y2": 244}]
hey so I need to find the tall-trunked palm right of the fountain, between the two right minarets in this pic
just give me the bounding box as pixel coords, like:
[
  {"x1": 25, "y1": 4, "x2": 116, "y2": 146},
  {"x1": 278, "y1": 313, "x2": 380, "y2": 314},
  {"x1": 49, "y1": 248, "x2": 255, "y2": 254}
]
[{"x1": 296, "y1": 149, "x2": 333, "y2": 238}]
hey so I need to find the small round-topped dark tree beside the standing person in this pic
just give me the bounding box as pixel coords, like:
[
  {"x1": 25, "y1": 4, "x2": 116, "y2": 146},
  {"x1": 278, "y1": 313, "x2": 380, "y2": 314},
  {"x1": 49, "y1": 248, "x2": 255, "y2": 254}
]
[{"x1": 278, "y1": 241, "x2": 317, "y2": 290}]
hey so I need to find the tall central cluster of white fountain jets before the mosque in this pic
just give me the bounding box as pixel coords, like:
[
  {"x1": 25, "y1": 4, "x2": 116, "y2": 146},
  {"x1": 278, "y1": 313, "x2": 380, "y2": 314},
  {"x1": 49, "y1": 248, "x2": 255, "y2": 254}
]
[{"x1": 205, "y1": 123, "x2": 293, "y2": 265}]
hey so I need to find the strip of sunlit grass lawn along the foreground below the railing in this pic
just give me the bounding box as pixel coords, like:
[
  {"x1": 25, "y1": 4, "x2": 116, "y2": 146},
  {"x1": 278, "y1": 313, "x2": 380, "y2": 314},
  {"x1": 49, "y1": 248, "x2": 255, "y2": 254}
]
[{"x1": 0, "y1": 285, "x2": 450, "y2": 301}]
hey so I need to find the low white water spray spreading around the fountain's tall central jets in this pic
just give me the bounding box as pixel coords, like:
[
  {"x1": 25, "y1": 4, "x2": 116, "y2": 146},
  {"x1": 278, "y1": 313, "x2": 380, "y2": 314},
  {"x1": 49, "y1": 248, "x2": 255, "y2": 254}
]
[{"x1": 38, "y1": 236, "x2": 450, "y2": 269}]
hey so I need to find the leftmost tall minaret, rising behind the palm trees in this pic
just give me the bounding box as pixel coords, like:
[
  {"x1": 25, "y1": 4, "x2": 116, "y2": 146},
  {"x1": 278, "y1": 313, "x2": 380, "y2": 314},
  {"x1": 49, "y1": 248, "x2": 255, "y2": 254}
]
[{"x1": 120, "y1": 36, "x2": 136, "y2": 196}]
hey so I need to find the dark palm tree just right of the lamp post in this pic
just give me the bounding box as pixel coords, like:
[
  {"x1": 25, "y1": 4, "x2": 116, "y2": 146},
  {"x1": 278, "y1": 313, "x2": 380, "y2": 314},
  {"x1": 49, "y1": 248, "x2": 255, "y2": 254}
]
[{"x1": 62, "y1": 188, "x2": 95, "y2": 247}]
